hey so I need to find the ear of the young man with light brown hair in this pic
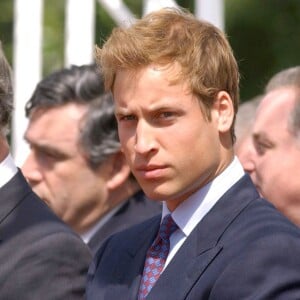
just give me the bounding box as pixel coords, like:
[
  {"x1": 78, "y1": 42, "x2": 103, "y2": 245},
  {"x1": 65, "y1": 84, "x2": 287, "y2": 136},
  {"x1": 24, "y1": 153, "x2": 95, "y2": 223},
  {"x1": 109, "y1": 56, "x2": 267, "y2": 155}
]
[{"x1": 213, "y1": 91, "x2": 234, "y2": 133}]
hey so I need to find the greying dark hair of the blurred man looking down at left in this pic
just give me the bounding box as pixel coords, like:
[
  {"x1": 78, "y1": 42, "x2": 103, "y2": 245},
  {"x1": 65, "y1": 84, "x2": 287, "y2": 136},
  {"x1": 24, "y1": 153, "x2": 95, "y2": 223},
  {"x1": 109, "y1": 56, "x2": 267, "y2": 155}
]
[{"x1": 25, "y1": 64, "x2": 120, "y2": 168}]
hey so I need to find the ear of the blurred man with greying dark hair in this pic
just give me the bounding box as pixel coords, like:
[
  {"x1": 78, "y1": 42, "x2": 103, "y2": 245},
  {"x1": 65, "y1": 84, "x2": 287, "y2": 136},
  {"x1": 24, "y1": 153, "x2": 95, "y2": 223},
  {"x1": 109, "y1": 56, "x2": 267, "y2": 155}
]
[{"x1": 106, "y1": 151, "x2": 130, "y2": 190}]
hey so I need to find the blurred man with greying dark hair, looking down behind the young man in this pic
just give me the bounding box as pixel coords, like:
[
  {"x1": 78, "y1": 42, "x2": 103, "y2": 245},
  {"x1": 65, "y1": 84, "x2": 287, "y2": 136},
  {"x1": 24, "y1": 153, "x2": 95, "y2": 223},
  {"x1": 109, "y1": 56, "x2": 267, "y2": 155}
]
[{"x1": 23, "y1": 65, "x2": 161, "y2": 252}]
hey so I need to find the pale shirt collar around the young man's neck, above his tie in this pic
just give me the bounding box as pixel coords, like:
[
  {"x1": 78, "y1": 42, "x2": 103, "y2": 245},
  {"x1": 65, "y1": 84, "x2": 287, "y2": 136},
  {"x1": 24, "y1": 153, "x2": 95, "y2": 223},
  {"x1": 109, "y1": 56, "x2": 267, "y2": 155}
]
[{"x1": 162, "y1": 157, "x2": 245, "y2": 236}]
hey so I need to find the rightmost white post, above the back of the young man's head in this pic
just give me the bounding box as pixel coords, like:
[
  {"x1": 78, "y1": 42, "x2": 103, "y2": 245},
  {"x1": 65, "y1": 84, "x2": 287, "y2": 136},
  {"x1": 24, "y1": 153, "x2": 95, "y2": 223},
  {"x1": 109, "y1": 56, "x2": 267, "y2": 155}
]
[{"x1": 195, "y1": 0, "x2": 224, "y2": 30}]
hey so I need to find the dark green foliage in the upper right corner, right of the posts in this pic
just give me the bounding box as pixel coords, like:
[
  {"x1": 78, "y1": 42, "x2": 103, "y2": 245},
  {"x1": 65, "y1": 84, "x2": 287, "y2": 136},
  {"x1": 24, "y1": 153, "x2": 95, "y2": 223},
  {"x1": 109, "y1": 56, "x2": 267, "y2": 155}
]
[{"x1": 225, "y1": 0, "x2": 300, "y2": 100}]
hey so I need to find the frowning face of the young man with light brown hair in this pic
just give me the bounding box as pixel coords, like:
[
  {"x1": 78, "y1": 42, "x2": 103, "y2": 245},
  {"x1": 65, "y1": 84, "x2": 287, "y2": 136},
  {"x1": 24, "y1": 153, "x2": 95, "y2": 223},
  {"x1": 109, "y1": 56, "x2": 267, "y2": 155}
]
[{"x1": 113, "y1": 65, "x2": 231, "y2": 210}]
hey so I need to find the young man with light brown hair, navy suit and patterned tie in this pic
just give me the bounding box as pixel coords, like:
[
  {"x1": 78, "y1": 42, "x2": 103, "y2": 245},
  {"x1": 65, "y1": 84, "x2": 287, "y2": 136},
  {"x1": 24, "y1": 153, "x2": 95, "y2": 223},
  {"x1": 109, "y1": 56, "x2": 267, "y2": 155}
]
[{"x1": 87, "y1": 9, "x2": 300, "y2": 300}]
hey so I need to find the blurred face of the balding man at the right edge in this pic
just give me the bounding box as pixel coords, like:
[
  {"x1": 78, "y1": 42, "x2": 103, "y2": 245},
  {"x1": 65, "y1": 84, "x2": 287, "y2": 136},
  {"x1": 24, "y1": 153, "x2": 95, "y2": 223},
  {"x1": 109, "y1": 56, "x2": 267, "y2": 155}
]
[{"x1": 245, "y1": 88, "x2": 300, "y2": 224}]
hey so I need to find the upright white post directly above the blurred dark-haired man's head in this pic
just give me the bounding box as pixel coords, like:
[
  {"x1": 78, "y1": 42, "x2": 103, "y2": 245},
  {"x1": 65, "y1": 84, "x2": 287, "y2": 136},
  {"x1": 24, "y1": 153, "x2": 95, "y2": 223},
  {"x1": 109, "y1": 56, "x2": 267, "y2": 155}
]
[{"x1": 65, "y1": 0, "x2": 96, "y2": 67}]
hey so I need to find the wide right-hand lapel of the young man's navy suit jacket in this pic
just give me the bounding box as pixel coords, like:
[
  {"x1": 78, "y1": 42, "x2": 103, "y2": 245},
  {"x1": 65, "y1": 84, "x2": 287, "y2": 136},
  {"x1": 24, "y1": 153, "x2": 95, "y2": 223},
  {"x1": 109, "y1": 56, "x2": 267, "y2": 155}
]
[{"x1": 147, "y1": 175, "x2": 259, "y2": 300}]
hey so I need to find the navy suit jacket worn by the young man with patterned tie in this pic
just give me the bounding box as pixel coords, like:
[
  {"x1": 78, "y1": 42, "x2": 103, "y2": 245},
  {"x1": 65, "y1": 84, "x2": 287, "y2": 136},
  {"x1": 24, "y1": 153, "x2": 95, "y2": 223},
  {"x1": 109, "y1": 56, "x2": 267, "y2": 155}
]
[{"x1": 87, "y1": 175, "x2": 300, "y2": 300}]
